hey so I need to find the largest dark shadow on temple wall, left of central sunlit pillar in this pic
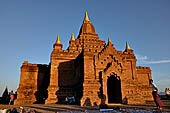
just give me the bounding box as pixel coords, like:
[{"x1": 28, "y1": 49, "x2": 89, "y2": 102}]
[{"x1": 56, "y1": 54, "x2": 83, "y2": 105}]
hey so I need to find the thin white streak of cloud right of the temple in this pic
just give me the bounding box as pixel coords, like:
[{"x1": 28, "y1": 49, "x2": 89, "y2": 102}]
[{"x1": 136, "y1": 54, "x2": 170, "y2": 64}]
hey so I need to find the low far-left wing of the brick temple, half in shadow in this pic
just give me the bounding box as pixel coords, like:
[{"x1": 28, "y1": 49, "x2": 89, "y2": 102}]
[{"x1": 14, "y1": 61, "x2": 49, "y2": 105}]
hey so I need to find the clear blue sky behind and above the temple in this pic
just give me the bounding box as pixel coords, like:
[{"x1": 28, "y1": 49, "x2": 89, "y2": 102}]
[{"x1": 0, "y1": 0, "x2": 170, "y2": 96}]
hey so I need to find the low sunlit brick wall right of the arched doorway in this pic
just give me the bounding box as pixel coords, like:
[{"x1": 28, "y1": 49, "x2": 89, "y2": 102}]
[{"x1": 119, "y1": 67, "x2": 152, "y2": 104}]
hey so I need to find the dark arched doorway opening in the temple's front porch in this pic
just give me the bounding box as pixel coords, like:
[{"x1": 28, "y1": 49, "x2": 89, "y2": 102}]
[{"x1": 107, "y1": 75, "x2": 122, "y2": 103}]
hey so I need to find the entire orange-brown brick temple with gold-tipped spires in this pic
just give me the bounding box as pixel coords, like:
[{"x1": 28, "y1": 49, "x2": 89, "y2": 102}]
[{"x1": 15, "y1": 12, "x2": 153, "y2": 106}]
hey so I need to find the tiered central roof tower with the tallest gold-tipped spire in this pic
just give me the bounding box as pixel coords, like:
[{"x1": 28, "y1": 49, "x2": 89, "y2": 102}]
[{"x1": 68, "y1": 11, "x2": 105, "y2": 53}]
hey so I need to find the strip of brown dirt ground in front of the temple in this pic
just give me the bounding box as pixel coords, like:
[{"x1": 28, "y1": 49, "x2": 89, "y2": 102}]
[{"x1": 0, "y1": 101, "x2": 170, "y2": 113}]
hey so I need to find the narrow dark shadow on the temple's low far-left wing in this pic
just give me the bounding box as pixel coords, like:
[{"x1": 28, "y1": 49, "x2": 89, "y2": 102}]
[{"x1": 34, "y1": 64, "x2": 50, "y2": 104}]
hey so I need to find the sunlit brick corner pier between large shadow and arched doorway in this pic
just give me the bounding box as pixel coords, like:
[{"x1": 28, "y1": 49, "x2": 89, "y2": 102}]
[{"x1": 80, "y1": 52, "x2": 100, "y2": 106}]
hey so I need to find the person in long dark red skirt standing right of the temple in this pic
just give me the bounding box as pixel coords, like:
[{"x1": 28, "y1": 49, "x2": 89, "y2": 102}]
[{"x1": 149, "y1": 79, "x2": 163, "y2": 110}]
